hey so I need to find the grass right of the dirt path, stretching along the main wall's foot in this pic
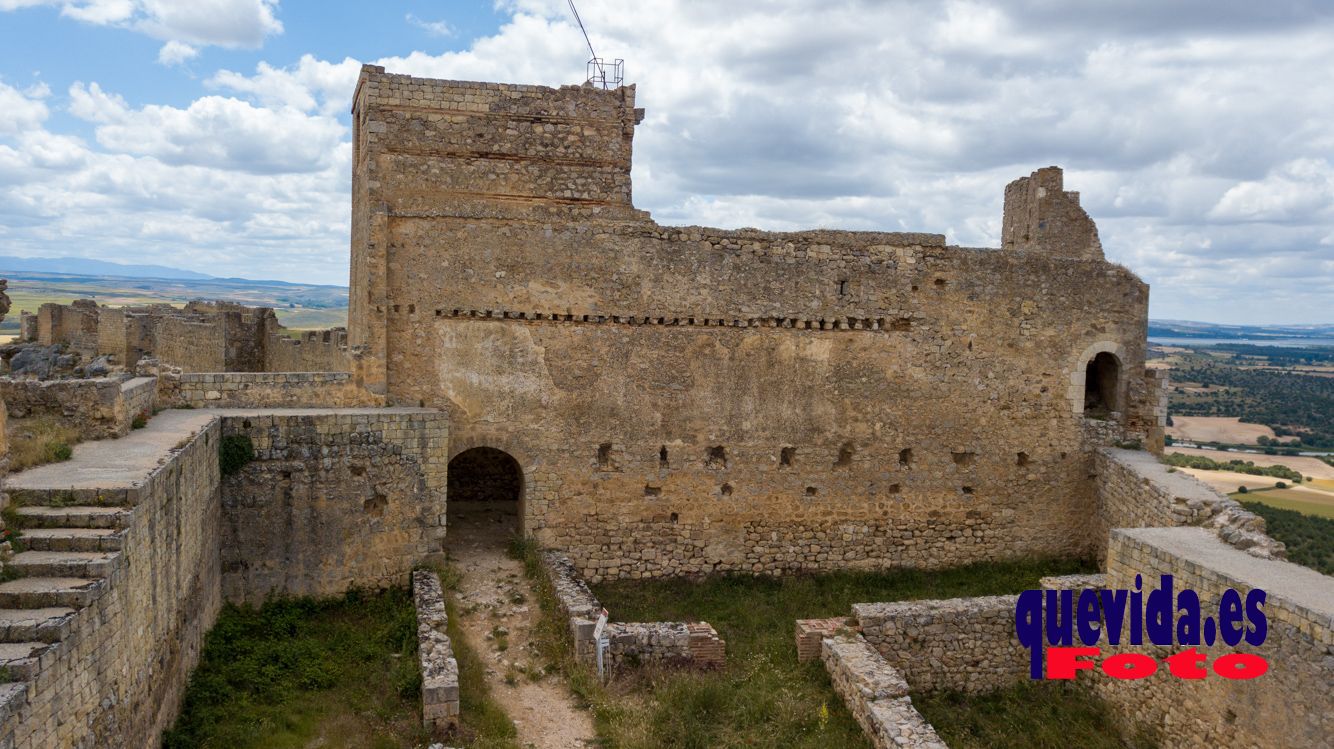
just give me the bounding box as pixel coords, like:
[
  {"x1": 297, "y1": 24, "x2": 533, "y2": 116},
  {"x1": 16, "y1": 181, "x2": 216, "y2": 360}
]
[{"x1": 527, "y1": 542, "x2": 1093, "y2": 749}]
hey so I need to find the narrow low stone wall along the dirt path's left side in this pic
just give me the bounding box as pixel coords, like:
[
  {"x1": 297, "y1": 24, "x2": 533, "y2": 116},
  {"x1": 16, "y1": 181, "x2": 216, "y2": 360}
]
[{"x1": 412, "y1": 570, "x2": 459, "y2": 738}]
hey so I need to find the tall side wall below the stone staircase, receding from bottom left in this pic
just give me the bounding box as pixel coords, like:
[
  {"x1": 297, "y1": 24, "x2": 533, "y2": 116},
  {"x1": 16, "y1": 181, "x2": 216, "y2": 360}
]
[{"x1": 0, "y1": 413, "x2": 221, "y2": 749}]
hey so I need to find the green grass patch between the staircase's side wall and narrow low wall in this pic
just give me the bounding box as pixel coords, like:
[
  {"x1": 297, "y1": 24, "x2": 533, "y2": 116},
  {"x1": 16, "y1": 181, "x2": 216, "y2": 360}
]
[{"x1": 163, "y1": 589, "x2": 428, "y2": 749}]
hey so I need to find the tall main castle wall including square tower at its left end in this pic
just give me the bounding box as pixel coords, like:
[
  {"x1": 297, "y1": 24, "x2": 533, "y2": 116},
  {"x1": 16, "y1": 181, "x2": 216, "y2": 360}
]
[{"x1": 350, "y1": 68, "x2": 1147, "y2": 581}]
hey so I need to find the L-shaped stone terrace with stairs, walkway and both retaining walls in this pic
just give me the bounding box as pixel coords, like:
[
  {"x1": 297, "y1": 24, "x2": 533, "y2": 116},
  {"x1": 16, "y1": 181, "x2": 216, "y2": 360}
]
[{"x1": 0, "y1": 409, "x2": 448, "y2": 749}]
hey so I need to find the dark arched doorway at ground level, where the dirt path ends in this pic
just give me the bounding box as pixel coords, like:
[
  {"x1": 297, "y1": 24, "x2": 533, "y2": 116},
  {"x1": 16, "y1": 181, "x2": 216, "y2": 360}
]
[{"x1": 446, "y1": 447, "x2": 523, "y2": 545}]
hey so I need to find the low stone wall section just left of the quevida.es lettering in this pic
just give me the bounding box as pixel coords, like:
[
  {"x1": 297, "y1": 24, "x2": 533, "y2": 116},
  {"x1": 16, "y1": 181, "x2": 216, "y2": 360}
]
[{"x1": 852, "y1": 595, "x2": 1029, "y2": 693}]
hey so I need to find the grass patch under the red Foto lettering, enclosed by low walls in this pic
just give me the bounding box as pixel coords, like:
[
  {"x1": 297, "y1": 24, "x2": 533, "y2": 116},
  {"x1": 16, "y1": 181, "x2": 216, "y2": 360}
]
[{"x1": 912, "y1": 681, "x2": 1154, "y2": 749}]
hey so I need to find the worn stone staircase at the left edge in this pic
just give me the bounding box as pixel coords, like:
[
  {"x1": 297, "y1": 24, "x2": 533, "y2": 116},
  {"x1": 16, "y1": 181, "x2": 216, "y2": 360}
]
[{"x1": 0, "y1": 493, "x2": 132, "y2": 702}]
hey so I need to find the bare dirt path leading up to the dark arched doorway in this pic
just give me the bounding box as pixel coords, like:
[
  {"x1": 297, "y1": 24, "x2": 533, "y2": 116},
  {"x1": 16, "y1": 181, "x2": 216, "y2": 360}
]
[{"x1": 448, "y1": 503, "x2": 596, "y2": 749}]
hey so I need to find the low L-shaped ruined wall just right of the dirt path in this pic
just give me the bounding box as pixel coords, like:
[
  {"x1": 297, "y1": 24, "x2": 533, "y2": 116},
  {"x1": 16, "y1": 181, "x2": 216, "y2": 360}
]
[{"x1": 542, "y1": 550, "x2": 727, "y2": 668}]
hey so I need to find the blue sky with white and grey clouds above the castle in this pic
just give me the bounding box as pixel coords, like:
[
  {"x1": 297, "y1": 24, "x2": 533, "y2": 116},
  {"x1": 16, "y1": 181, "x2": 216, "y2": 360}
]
[{"x1": 0, "y1": 0, "x2": 1334, "y2": 323}]
